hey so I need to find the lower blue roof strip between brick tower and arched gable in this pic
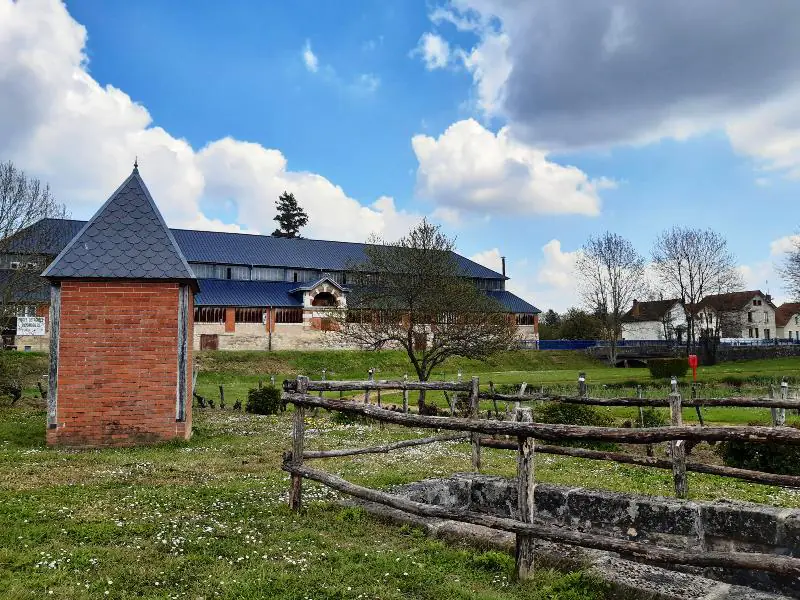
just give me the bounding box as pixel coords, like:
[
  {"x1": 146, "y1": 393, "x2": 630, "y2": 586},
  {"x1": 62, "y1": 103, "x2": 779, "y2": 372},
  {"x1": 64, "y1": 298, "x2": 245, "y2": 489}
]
[{"x1": 194, "y1": 279, "x2": 303, "y2": 306}]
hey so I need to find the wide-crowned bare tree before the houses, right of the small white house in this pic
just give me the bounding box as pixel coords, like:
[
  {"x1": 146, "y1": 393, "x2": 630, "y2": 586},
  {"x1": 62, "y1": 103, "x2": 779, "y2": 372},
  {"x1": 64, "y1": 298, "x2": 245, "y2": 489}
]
[{"x1": 653, "y1": 226, "x2": 741, "y2": 350}]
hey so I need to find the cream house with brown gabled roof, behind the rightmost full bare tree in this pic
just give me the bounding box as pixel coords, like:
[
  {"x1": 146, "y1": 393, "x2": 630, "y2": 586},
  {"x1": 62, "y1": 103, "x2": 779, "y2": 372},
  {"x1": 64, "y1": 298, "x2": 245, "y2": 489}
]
[{"x1": 695, "y1": 290, "x2": 778, "y2": 340}]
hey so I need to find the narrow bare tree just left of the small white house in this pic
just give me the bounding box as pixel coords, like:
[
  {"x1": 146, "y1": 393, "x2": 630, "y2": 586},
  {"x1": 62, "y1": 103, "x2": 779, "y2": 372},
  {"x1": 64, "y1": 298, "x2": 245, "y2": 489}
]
[{"x1": 577, "y1": 231, "x2": 645, "y2": 364}]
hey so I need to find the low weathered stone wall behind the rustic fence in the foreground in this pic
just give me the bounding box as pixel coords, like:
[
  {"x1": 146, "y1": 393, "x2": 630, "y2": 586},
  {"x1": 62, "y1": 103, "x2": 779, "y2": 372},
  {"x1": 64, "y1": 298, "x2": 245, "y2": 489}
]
[{"x1": 399, "y1": 474, "x2": 800, "y2": 598}]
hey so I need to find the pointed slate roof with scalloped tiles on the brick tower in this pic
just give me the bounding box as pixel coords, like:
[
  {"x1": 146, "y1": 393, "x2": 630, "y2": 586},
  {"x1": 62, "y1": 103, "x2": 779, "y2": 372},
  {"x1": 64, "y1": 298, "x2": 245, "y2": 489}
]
[{"x1": 42, "y1": 167, "x2": 196, "y2": 284}]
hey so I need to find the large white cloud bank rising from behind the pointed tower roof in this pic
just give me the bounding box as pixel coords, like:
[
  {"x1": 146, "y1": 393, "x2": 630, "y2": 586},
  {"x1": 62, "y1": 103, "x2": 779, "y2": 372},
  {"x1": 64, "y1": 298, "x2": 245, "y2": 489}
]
[{"x1": 0, "y1": 0, "x2": 404, "y2": 241}]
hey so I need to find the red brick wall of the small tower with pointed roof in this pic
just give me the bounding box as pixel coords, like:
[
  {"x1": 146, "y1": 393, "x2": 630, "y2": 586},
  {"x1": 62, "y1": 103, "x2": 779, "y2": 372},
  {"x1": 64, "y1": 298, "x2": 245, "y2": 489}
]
[{"x1": 47, "y1": 281, "x2": 193, "y2": 446}]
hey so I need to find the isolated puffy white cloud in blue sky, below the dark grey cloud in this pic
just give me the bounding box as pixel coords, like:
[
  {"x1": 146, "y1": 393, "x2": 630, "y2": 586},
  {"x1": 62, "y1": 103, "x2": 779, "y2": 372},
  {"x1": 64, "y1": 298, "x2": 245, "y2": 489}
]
[{"x1": 411, "y1": 119, "x2": 613, "y2": 215}]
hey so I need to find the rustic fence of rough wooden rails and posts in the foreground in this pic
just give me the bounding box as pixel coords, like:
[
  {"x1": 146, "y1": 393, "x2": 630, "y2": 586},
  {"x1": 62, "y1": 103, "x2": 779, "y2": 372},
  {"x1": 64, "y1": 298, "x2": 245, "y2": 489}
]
[{"x1": 283, "y1": 377, "x2": 800, "y2": 578}]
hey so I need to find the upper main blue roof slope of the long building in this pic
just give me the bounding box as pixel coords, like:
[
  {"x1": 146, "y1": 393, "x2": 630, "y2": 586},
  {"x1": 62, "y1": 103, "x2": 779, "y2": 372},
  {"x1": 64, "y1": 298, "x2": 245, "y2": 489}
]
[{"x1": 18, "y1": 219, "x2": 504, "y2": 279}]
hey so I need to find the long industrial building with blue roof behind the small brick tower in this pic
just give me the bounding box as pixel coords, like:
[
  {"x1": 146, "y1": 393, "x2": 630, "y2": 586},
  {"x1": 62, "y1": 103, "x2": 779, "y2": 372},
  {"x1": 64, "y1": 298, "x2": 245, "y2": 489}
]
[{"x1": 0, "y1": 205, "x2": 540, "y2": 350}]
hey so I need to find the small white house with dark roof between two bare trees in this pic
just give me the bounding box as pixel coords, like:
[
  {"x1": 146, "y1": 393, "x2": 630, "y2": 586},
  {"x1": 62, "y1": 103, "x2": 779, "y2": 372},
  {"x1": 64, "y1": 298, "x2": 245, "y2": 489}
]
[{"x1": 622, "y1": 298, "x2": 687, "y2": 342}]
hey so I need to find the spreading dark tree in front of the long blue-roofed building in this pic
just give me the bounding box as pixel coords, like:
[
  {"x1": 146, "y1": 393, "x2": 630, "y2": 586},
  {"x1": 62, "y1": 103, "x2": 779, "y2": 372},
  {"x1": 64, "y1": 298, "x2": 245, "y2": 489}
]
[{"x1": 337, "y1": 220, "x2": 517, "y2": 409}]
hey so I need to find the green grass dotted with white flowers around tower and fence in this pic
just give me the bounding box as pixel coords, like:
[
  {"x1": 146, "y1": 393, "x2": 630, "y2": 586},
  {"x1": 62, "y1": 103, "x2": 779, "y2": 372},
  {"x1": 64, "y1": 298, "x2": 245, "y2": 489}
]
[{"x1": 0, "y1": 352, "x2": 800, "y2": 600}]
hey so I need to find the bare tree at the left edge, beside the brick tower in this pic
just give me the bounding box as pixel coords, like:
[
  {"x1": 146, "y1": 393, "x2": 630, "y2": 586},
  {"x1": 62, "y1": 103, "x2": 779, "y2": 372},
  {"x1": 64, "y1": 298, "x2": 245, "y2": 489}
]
[{"x1": 0, "y1": 161, "x2": 66, "y2": 328}]
